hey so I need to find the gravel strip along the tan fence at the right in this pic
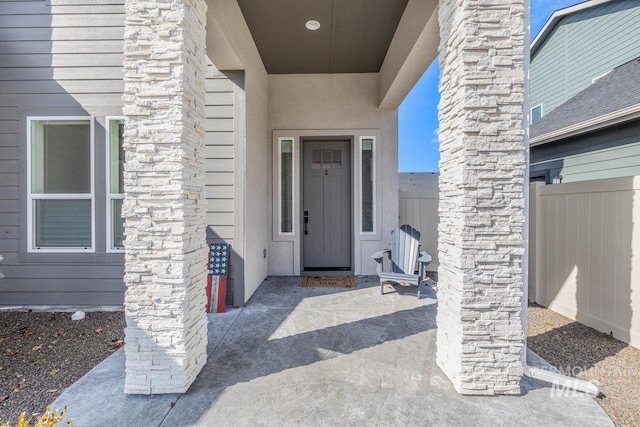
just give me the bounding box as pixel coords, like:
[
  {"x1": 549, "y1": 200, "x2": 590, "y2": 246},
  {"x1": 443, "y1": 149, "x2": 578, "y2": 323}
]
[{"x1": 527, "y1": 304, "x2": 640, "y2": 427}]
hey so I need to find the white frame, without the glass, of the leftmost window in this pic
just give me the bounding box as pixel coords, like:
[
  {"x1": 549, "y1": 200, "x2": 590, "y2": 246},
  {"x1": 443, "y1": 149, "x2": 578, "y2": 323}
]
[{"x1": 27, "y1": 116, "x2": 96, "y2": 253}]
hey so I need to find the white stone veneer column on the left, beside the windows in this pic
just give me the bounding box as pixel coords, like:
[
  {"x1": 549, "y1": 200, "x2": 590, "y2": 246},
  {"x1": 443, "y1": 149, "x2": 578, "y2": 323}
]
[{"x1": 123, "y1": 0, "x2": 207, "y2": 394}]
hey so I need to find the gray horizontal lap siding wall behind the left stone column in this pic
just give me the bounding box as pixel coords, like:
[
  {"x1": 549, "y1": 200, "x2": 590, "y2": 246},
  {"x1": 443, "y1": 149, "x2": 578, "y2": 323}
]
[{"x1": 0, "y1": 0, "x2": 244, "y2": 306}]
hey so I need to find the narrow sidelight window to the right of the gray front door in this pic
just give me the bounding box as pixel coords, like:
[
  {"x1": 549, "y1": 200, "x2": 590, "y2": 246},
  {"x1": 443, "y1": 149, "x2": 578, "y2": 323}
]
[{"x1": 360, "y1": 138, "x2": 375, "y2": 233}]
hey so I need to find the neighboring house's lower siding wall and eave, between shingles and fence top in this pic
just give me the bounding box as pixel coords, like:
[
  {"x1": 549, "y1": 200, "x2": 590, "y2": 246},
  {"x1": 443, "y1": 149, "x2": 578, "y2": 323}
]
[{"x1": 531, "y1": 120, "x2": 640, "y2": 183}]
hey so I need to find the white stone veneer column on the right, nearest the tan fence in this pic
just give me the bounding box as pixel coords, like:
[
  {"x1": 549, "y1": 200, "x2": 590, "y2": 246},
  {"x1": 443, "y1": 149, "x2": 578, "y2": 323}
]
[{"x1": 436, "y1": 0, "x2": 527, "y2": 395}]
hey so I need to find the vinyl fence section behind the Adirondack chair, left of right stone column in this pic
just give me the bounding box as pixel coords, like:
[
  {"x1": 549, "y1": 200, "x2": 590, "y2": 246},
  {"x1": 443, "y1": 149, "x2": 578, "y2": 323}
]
[{"x1": 399, "y1": 189, "x2": 440, "y2": 271}]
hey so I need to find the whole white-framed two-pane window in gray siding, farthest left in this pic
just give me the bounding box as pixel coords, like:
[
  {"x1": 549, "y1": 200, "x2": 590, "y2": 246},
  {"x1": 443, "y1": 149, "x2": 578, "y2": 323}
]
[{"x1": 27, "y1": 118, "x2": 94, "y2": 252}]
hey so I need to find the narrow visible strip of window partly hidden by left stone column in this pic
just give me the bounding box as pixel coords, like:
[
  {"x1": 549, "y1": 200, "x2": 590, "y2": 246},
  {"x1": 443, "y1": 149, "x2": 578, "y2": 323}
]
[{"x1": 107, "y1": 118, "x2": 124, "y2": 252}]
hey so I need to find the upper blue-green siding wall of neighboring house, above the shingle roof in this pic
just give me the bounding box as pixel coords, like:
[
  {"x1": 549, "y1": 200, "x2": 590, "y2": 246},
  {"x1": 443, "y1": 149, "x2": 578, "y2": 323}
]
[{"x1": 530, "y1": 0, "x2": 640, "y2": 114}]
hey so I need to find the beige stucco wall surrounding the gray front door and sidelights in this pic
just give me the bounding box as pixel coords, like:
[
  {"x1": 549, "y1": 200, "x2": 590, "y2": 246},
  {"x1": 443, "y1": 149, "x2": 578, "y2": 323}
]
[{"x1": 269, "y1": 74, "x2": 398, "y2": 275}]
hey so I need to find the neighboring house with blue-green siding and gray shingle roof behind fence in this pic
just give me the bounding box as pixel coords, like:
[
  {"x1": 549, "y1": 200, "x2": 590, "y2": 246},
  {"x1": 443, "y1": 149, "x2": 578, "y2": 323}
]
[{"x1": 529, "y1": 0, "x2": 640, "y2": 184}]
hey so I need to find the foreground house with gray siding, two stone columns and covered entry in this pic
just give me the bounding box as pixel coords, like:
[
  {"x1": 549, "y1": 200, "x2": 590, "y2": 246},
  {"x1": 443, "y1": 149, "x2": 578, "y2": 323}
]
[{"x1": 0, "y1": 0, "x2": 528, "y2": 394}]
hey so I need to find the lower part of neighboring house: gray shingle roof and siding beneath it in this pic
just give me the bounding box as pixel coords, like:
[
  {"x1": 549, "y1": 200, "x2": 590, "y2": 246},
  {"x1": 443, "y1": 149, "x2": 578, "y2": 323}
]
[{"x1": 530, "y1": 58, "x2": 640, "y2": 183}]
